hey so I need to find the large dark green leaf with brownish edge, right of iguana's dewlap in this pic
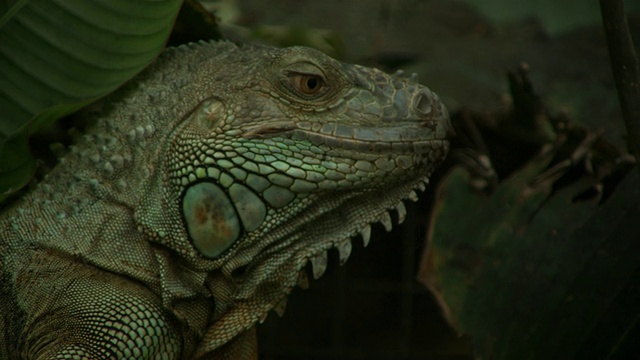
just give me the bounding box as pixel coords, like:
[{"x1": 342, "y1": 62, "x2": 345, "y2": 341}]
[{"x1": 421, "y1": 156, "x2": 640, "y2": 359}]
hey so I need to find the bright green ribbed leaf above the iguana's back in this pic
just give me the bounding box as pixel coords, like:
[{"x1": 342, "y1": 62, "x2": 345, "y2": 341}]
[{"x1": 0, "y1": 0, "x2": 181, "y2": 197}]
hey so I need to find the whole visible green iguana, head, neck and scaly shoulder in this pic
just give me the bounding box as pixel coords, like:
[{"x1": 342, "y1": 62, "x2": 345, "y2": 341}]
[{"x1": 0, "y1": 42, "x2": 450, "y2": 359}]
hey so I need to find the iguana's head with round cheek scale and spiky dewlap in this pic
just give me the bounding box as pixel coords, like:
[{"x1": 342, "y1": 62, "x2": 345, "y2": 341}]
[{"x1": 134, "y1": 43, "x2": 450, "y2": 349}]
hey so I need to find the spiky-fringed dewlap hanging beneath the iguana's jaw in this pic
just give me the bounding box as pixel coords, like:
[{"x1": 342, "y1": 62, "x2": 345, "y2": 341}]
[{"x1": 198, "y1": 165, "x2": 444, "y2": 353}]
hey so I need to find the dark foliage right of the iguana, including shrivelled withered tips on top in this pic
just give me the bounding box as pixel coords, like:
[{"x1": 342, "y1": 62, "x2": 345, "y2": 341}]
[{"x1": 419, "y1": 69, "x2": 640, "y2": 359}]
